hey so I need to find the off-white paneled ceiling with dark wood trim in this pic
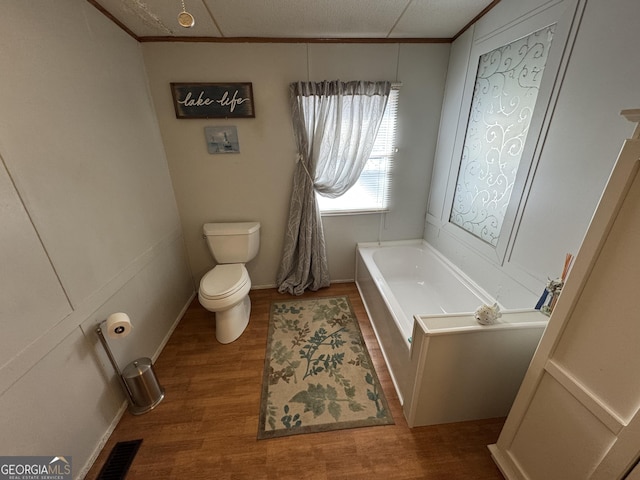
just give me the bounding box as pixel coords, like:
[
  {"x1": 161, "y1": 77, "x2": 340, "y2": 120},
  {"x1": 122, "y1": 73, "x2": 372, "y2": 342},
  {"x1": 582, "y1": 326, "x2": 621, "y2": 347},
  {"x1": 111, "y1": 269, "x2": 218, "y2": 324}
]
[{"x1": 88, "y1": 0, "x2": 500, "y2": 41}]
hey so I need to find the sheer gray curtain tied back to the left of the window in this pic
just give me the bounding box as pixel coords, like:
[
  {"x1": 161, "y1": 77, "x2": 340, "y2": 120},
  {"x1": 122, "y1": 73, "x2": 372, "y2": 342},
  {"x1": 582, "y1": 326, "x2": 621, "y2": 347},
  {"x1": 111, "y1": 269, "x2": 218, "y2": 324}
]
[{"x1": 276, "y1": 81, "x2": 391, "y2": 295}]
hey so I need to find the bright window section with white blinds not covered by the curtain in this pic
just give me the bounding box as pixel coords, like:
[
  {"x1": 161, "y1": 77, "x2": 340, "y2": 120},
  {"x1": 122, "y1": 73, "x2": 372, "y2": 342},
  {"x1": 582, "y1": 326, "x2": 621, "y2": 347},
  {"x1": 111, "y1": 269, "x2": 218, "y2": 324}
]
[{"x1": 316, "y1": 85, "x2": 400, "y2": 215}]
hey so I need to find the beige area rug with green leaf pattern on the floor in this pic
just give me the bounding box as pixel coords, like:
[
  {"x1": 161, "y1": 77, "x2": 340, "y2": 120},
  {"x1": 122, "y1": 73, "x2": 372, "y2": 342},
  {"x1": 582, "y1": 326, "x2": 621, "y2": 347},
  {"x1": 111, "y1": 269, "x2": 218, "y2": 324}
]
[{"x1": 258, "y1": 297, "x2": 394, "y2": 439}]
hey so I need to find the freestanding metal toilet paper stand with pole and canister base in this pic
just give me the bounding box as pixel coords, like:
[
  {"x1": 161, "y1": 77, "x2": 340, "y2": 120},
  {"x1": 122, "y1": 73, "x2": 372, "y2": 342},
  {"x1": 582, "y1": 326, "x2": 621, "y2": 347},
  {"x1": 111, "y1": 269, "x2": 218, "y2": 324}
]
[{"x1": 96, "y1": 320, "x2": 164, "y2": 415}]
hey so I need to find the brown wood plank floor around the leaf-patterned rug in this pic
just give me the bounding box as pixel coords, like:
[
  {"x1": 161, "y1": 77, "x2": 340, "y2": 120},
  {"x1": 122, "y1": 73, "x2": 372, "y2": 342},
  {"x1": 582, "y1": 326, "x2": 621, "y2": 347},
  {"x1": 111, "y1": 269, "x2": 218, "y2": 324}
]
[{"x1": 86, "y1": 283, "x2": 504, "y2": 480}]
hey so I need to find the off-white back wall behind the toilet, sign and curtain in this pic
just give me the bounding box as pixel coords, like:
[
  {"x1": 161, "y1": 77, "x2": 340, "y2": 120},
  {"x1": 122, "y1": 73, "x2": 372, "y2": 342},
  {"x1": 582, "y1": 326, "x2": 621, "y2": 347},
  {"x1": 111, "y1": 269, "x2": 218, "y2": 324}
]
[{"x1": 142, "y1": 43, "x2": 449, "y2": 286}]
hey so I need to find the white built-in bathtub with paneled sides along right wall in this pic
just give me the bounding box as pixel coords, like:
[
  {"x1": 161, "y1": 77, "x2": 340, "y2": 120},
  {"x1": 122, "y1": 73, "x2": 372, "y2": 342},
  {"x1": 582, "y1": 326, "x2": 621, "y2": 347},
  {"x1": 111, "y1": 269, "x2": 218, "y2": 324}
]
[{"x1": 356, "y1": 240, "x2": 547, "y2": 426}]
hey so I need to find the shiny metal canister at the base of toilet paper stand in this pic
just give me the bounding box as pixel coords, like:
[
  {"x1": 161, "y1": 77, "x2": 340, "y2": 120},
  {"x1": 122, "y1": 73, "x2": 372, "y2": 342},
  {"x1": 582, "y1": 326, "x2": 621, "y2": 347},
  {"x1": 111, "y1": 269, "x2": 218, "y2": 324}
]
[{"x1": 122, "y1": 357, "x2": 164, "y2": 415}]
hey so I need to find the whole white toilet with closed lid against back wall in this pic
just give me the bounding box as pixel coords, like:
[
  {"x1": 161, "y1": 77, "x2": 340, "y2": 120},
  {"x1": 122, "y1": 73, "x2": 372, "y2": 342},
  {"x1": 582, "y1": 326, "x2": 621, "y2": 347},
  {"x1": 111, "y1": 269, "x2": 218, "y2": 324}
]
[{"x1": 198, "y1": 222, "x2": 260, "y2": 343}]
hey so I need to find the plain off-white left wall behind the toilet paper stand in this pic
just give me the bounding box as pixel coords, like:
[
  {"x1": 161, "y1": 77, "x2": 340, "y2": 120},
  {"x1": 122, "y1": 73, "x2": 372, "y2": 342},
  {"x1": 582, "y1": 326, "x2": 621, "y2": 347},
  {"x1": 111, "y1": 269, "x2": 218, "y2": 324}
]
[{"x1": 0, "y1": 0, "x2": 193, "y2": 476}]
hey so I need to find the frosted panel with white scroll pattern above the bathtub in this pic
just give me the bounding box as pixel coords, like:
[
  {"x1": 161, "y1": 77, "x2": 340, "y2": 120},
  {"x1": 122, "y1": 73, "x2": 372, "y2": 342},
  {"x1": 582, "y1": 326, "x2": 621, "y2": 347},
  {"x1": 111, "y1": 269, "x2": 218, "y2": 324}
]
[{"x1": 450, "y1": 25, "x2": 555, "y2": 247}]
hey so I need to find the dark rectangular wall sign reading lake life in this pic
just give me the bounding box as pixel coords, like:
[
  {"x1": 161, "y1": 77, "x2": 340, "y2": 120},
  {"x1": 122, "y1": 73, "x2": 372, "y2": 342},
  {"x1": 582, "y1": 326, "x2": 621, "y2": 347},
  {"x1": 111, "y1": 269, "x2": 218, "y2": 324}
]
[{"x1": 171, "y1": 83, "x2": 256, "y2": 118}]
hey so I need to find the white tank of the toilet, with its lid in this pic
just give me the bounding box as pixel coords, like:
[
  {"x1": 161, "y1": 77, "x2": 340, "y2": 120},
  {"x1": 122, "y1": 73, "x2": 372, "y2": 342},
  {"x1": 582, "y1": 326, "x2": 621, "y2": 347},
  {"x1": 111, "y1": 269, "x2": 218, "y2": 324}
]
[{"x1": 202, "y1": 222, "x2": 260, "y2": 263}]
